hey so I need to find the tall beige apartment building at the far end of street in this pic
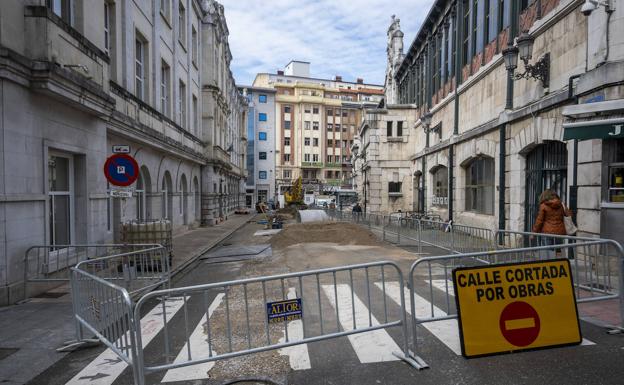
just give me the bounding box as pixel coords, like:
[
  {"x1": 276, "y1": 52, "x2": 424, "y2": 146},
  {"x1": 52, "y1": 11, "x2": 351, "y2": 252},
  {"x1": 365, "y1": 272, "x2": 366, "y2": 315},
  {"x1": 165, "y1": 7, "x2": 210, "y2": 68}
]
[{"x1": 254, "y1": 61, "x2": 383, "y2": 200}]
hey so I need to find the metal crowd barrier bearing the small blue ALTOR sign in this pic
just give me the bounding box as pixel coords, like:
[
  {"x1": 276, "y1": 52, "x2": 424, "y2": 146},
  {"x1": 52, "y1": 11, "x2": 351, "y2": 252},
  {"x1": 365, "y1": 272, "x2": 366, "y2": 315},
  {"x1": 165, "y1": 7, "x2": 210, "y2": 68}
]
[{"x1": 134, "y1": 262, "x2": 420, "y2": 385}]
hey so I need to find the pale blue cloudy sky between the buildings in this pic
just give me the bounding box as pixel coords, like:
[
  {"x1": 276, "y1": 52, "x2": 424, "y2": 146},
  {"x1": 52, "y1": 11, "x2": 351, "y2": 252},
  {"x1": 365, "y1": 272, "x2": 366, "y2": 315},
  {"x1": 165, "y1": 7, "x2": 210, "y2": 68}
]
[{"x1": 219, "y1": 0, "x2": 433, "y2": 85}]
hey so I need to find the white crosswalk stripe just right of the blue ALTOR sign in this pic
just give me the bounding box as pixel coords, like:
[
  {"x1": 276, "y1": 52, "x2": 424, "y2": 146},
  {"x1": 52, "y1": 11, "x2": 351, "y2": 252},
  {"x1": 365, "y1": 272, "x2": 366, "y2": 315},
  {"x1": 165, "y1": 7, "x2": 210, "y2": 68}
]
[{"x1": 323, "y1": 285, "x2": 401, "y2": 363}]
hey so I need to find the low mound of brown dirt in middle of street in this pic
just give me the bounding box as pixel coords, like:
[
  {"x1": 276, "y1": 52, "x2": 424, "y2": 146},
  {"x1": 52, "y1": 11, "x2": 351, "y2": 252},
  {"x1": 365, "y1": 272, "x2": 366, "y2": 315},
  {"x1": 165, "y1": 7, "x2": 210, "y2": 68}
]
[{"x1": 271, "y1": 222, "x2": 381, "y2": 249}]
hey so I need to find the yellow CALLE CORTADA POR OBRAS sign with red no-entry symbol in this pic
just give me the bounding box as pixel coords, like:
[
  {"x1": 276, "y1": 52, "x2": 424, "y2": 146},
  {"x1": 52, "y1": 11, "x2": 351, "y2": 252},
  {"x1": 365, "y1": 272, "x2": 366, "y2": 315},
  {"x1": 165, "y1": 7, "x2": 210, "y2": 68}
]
[{"x1": 453, "y1": 259, "x2": 582, "y2": 357}]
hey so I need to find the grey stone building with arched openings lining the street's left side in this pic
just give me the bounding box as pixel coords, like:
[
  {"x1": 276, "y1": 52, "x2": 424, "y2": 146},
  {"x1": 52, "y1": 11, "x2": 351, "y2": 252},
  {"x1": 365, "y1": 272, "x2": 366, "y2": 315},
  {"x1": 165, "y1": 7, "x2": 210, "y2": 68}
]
[{"x1": 0, "y1": 0, "x2": 246, "y2": 304}]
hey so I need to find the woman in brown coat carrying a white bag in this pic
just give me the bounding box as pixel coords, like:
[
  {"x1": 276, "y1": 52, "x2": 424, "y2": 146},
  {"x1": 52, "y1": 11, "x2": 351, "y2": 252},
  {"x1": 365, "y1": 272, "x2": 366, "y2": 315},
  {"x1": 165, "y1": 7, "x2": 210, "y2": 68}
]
[{"x1": 533, "y1": 189, "x2": 571, "y2": 254}]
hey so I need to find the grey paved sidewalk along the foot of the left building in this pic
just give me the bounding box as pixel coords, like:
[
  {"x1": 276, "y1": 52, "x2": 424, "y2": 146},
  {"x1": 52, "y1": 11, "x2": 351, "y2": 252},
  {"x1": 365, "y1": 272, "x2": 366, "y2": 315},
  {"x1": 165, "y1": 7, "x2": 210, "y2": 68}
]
[{"x1": 0, "y1": 213, "x2": 256, "y2": 385}]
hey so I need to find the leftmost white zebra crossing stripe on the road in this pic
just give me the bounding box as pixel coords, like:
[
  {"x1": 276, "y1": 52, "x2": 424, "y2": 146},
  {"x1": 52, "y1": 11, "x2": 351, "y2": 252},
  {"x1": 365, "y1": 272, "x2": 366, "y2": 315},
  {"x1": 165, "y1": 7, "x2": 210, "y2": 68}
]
[{"x1": 66, "y1": 297, "x2": 190, "y2": 385}]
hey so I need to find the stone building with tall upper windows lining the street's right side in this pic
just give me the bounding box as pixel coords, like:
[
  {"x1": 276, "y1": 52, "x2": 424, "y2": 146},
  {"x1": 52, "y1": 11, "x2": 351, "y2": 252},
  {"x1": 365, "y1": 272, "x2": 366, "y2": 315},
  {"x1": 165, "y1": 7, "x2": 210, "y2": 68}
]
[{"x1": 356, "y1": 0, "x2": 624, "y2": 246}]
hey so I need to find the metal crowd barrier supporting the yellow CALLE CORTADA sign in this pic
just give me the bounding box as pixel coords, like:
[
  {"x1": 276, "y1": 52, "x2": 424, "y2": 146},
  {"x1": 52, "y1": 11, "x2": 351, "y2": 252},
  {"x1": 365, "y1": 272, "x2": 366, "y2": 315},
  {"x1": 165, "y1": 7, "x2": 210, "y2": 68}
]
[{"x1": 408, "y1": 237, "x2": 624, "y2": 361}]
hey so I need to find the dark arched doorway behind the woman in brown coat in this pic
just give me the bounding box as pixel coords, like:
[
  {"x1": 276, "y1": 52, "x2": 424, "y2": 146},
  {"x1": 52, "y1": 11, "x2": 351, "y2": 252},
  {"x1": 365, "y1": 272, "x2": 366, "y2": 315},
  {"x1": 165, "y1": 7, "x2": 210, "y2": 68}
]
[{"x1": 524, "y1": 141, "x2": 568, "y2": 231}]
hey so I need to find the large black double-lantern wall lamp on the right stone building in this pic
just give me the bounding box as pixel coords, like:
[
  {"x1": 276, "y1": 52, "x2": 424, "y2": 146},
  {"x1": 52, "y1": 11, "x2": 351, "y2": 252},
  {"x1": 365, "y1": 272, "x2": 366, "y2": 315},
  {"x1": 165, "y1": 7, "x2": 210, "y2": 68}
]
[{"x1": 503, "y1": 32, "x2": 550, "y2": 88}]
